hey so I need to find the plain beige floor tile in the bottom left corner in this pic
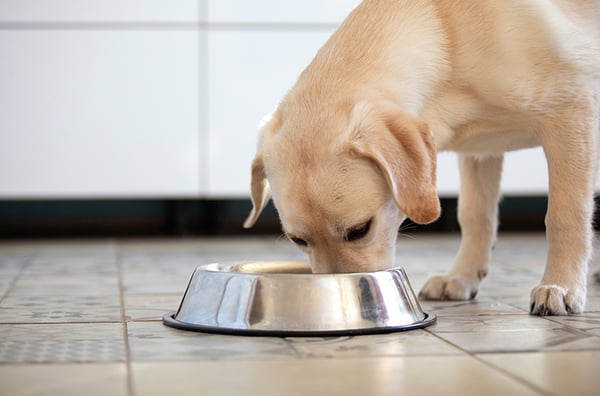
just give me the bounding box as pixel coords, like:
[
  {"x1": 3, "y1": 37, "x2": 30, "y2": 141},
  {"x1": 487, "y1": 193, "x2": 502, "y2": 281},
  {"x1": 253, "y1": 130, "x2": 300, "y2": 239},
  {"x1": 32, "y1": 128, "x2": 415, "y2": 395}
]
[{"x1": 0, "y1": 363, "x2": 127, "y2": 396}]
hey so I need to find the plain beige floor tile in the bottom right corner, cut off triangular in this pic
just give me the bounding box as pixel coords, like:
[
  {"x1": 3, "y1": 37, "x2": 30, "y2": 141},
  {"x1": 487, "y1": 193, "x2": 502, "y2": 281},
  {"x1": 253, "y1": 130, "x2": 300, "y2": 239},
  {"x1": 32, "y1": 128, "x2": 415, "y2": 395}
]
[{"x1": 479, "y1": 351, "x2": 600, "y2": 396}]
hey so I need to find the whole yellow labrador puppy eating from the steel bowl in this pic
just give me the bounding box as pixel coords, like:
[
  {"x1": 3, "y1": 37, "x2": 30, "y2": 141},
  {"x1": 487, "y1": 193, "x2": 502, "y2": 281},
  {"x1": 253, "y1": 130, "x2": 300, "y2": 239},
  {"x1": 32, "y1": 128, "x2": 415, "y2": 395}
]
[{"x1": 245, "y1": 0, "x2": 600, "y2": 315}]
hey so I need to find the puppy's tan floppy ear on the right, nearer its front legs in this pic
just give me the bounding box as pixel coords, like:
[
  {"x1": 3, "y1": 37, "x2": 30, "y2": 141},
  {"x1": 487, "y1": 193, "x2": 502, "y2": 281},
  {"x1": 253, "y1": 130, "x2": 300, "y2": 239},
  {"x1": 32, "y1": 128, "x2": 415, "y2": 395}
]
[{"x1": 346, "y1": 102, "x2": 441, "y2": 224}]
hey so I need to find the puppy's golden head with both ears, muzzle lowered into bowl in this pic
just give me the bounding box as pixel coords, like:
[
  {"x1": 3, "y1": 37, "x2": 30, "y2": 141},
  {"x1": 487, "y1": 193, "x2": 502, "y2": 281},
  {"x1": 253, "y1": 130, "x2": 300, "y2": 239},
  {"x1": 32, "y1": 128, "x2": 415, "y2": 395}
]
[{"x1": 244, "y1": 101, "x2": 440, "y2": 273}]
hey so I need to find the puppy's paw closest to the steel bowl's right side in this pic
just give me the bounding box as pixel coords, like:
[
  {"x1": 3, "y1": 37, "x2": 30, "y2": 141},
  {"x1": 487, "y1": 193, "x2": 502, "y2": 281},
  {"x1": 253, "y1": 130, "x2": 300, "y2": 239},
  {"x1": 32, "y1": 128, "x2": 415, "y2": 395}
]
[{"x1": 419, "y1": 274, "x2": 479, "y2": 300}]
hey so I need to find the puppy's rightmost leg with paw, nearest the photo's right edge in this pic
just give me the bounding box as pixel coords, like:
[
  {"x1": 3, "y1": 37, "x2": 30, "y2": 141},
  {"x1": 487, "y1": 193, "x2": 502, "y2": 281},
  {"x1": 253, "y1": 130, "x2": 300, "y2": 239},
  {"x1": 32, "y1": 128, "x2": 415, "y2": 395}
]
[{"x1": 531, "y1": 112, "x2": 598, "y2": 315}]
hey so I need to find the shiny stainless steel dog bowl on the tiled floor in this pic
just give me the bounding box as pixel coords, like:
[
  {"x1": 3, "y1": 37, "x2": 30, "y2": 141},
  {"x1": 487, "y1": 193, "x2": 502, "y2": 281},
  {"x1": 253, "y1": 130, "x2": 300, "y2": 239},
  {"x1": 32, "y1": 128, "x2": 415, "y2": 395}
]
[{"x1": 163, "y1": 261, "x2": 436, "y2": 336}]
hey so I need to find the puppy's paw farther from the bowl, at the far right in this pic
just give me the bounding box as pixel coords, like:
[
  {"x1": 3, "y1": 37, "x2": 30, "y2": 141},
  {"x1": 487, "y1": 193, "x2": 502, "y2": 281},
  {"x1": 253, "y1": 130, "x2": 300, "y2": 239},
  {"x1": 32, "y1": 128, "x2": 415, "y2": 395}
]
[{"x1": 531, "y1": 285, "x2": 585, "y2": 316}]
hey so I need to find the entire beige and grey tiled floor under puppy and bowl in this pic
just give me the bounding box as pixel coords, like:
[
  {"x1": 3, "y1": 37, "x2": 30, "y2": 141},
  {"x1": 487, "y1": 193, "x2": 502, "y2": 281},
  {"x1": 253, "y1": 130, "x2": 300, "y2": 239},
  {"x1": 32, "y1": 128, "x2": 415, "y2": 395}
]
[{"x1": 0, "y1": 234, "x2": 600, "y2": 396}]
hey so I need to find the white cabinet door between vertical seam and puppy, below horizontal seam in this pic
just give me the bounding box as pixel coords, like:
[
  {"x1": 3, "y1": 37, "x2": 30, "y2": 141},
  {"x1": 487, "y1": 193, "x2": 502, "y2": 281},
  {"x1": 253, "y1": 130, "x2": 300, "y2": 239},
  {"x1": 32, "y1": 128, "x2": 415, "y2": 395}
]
[{"x1": 208, "y1": 31, "x2": 331, "y2": 197}]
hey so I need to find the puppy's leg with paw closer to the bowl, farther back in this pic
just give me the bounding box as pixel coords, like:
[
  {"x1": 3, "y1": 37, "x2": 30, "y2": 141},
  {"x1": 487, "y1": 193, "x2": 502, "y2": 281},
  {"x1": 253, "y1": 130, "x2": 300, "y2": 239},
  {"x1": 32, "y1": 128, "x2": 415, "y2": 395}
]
[{"x1": 419, "y1": 154, "x2": 503, "y2": 300}]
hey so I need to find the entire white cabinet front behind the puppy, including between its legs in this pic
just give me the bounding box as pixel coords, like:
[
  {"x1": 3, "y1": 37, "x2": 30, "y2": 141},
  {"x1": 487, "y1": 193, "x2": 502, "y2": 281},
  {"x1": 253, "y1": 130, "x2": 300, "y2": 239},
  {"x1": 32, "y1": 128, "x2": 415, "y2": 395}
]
[{"x1": 0, "y1": 0, "x2": 568, "y2": 198}]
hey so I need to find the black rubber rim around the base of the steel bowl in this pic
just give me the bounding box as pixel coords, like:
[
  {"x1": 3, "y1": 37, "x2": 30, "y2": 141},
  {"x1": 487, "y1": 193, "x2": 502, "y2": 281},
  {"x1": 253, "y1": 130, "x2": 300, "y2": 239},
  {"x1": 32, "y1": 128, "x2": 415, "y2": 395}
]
[{"x1": 163, "y1": 311, "x2": 437, "y2": 337}]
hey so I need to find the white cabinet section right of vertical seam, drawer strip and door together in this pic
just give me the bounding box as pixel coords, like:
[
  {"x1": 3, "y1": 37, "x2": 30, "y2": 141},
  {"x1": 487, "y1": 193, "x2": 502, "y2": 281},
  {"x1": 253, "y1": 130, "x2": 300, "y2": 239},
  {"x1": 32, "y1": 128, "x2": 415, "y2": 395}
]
[{"x1": 207, "y1": 0, "x2": 359, "y2": 197}]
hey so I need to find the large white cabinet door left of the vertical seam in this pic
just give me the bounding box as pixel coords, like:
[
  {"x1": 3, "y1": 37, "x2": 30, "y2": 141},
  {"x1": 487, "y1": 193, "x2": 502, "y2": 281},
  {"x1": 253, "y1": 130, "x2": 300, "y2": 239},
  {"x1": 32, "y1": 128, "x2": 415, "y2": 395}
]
[{"x1": 0, "y1": 27, "x2": 203, "y2": 198}]
